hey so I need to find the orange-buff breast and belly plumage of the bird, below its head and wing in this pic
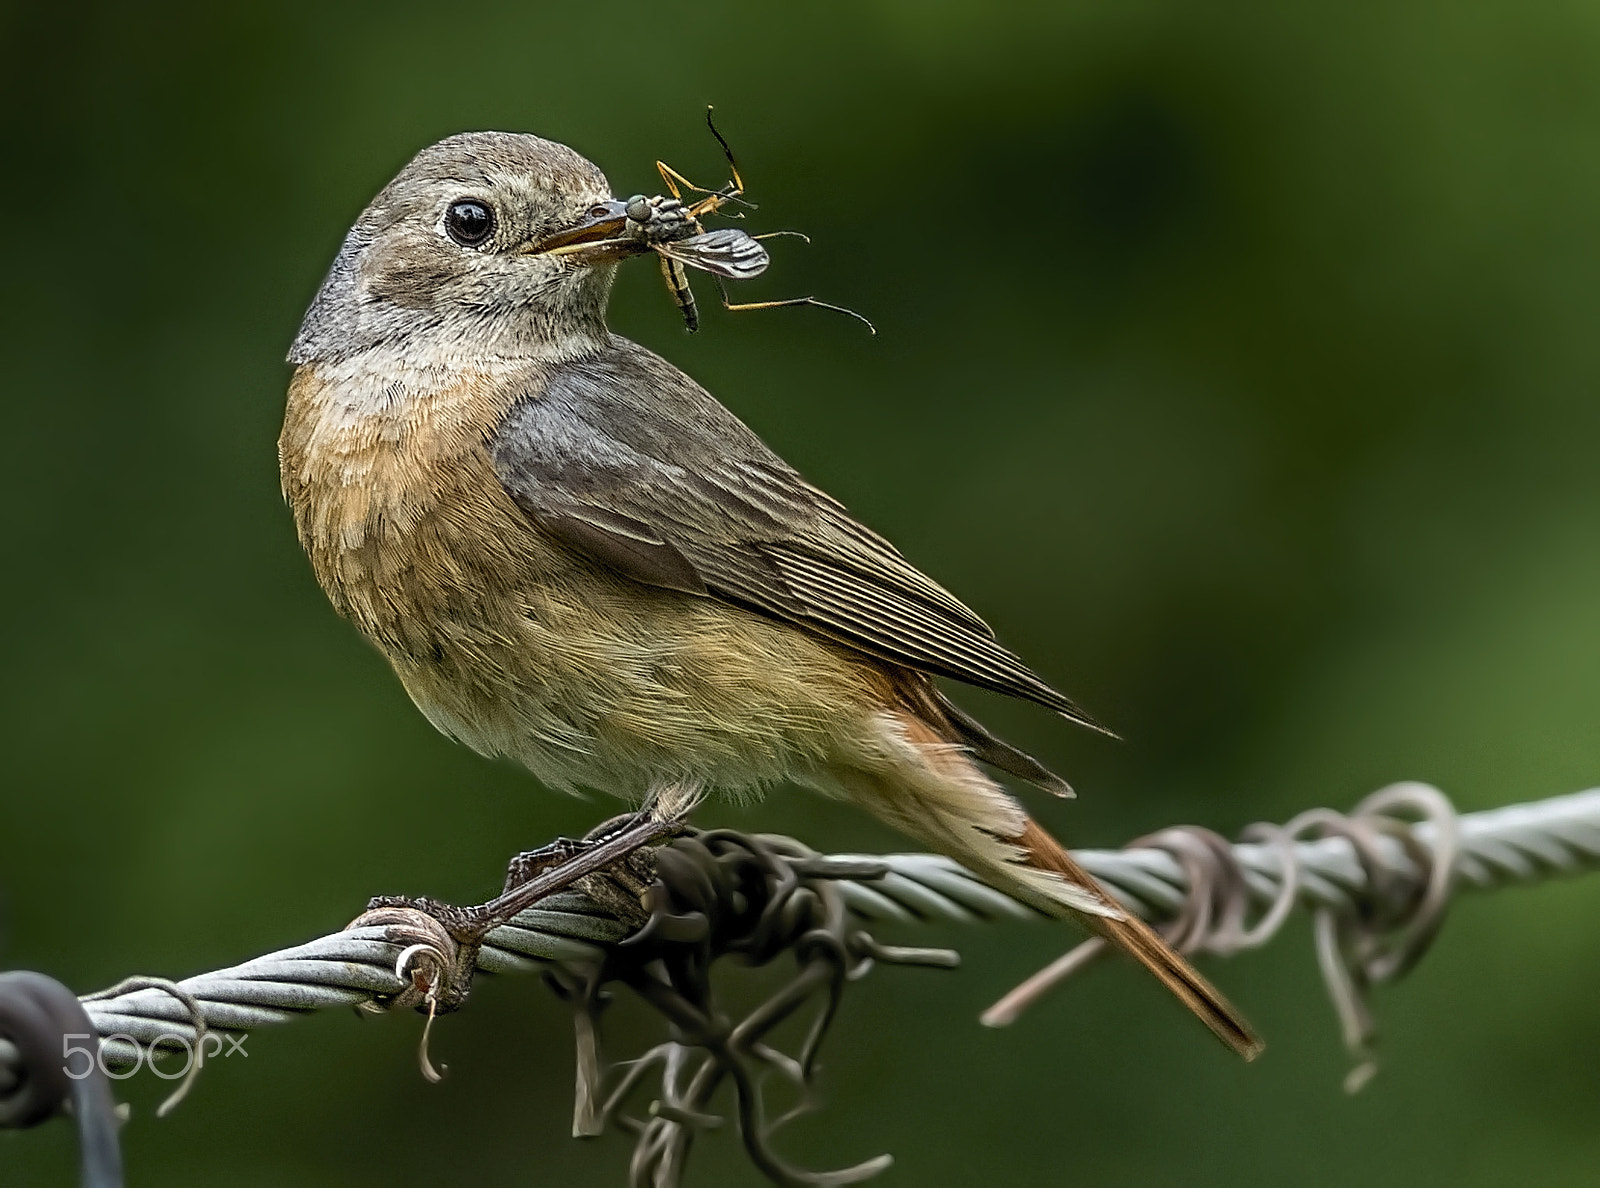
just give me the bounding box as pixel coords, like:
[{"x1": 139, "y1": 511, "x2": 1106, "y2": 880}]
[{"x1": 280, "y1": 355, "x2": 882, "y2": 794}]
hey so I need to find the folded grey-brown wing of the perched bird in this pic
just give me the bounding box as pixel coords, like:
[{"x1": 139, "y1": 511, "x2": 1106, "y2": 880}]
[{"x1": 491, "y1": 338, "x2": 1099, "y2": 728}]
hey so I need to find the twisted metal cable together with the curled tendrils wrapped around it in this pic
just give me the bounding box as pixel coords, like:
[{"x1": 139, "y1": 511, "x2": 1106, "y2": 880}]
[{"x1": 9, "y1": 785, "x2": 1600, "y2": 1188}]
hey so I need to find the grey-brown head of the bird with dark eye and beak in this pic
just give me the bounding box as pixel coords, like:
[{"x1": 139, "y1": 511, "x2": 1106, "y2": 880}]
[{"x1": 288, "y1": 131, "x2": 643, "y2": 363}]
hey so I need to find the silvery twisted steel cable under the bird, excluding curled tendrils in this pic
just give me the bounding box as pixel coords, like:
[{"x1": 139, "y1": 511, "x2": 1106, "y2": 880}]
[{"x1": 0, "y1": 789, "x2": 1600, "y2": 1094}]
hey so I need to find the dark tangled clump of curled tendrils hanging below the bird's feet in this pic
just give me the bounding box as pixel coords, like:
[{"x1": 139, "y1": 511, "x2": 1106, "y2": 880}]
[{"x1": 552, "y1": 829, "x2": 957, "y2": 1188}]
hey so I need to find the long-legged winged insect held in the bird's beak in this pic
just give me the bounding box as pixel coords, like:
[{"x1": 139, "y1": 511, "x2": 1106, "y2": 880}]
[{"x1": 624, "y1": 107, "x2": 877, "y2": 335}]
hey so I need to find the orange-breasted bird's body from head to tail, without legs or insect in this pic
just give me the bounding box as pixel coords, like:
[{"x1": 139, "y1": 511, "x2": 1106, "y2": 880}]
[{"x1": 280, "y1": 131, "x2": 1261, "y2": 1058}]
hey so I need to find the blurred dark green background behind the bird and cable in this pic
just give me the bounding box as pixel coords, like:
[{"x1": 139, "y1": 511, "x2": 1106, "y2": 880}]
[{"x1": 0, "y1": 0, "x2": 1600, "y2": 1188}]
